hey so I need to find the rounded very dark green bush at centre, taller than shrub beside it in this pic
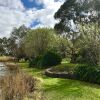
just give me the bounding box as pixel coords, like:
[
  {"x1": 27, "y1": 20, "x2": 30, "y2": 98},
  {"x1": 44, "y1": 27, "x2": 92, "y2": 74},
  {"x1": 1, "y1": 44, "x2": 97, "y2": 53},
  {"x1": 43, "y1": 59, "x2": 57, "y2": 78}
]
[{"x1": 42, "y1": 51, "x2": 62, "y2": 67}]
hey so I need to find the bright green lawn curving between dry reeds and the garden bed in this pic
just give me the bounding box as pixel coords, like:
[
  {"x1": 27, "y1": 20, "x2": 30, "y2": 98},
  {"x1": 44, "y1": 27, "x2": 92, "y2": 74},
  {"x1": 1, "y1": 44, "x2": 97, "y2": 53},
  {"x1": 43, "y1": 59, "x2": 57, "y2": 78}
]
[{"x1": 20, "y1": 63, "x2": 100, "y2": 100}]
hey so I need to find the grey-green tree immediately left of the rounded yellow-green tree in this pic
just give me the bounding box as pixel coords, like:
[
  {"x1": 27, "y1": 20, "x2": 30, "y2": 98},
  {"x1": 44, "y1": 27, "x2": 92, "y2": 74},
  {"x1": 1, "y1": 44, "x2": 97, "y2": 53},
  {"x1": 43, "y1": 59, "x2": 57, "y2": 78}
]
[{"x1": 9, "y1": 25, "x2": 29, "y2": 59}]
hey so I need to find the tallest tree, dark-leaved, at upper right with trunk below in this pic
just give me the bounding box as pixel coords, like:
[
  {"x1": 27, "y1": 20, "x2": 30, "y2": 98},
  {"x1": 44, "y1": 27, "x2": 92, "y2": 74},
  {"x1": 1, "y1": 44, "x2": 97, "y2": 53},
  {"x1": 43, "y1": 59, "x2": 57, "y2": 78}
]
[{"x1": 54, "y1": 0, "x2": 100, "y2": 62}]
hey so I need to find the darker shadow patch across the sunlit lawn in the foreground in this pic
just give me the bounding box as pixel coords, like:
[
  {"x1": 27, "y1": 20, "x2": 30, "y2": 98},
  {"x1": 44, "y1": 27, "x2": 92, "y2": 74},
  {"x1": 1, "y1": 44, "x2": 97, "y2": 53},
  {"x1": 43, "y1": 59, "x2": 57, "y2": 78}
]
[{"x1": 45, "y1": 79, "x2": 82, "y2": 95}]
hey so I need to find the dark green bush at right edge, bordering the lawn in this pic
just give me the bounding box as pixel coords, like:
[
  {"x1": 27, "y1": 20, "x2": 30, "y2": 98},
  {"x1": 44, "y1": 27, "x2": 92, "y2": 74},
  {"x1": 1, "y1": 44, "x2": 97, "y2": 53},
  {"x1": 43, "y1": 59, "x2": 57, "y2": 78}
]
[{"x1": 74, "y1": 66, "x2": 100, "y2": 84}]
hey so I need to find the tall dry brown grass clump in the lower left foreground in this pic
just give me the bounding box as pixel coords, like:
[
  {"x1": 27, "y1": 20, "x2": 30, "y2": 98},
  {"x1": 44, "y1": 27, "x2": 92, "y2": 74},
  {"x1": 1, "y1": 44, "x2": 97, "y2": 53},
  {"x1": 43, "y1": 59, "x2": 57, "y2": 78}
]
[{"x1": 1, "y1": 72, "x2": 40, "y2": 100}]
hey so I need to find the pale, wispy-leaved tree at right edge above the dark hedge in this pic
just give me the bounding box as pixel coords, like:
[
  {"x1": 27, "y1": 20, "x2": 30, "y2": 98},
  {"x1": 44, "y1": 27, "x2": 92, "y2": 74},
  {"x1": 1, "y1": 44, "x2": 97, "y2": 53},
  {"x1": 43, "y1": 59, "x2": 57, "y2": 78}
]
[{"x1": 77, "y1": 24, "x2": 100, "y2": 65}]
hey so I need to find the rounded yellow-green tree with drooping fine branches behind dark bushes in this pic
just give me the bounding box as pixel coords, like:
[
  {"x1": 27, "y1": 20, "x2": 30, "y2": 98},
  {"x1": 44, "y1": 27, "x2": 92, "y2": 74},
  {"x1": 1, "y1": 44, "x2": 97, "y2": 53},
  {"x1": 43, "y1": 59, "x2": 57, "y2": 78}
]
[{"x1": 24, "y1": 28, "x2": 55, "y2": 57}]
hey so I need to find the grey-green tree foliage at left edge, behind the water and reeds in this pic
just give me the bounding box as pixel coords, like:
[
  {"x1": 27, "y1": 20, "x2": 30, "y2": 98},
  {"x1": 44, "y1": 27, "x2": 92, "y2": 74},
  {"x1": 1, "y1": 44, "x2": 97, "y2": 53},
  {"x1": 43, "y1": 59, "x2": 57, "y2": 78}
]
[{"x1": 0, "y1": 25, "x2": 28, "y2": 59}]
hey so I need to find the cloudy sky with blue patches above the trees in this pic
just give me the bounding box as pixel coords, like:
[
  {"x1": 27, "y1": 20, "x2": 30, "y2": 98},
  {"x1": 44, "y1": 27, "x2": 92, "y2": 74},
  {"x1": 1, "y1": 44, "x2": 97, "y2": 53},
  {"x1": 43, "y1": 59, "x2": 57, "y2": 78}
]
[{"x1": 0, "y1": 0, "x2": 65, "y2": 38}]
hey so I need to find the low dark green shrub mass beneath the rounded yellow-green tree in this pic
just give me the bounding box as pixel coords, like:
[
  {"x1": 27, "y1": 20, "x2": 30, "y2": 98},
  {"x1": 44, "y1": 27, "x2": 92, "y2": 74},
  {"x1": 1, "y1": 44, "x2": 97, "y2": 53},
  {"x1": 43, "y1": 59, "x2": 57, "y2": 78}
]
[{"x1": 29, "y1": 51, "x2": 61, "y2": 68}]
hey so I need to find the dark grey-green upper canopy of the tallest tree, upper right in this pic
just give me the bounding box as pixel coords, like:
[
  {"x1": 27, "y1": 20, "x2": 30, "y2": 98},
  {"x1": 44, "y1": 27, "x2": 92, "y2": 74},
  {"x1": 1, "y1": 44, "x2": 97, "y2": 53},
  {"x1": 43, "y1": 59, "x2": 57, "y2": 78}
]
[{"x1": 54, "y1": 0, "x2": 100, "y2": 35}]
